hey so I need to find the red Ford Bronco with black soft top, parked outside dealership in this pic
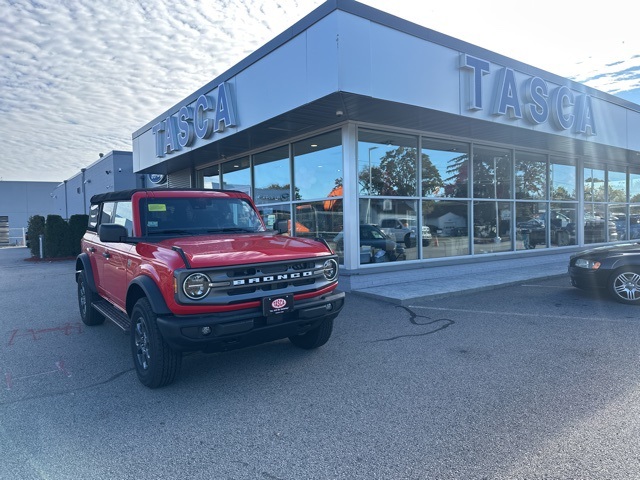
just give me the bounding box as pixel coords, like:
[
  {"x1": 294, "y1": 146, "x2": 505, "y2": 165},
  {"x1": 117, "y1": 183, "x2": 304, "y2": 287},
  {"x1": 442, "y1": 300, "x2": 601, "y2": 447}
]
[{"x1": 76, "y1": 189, "x2": 345, "y2": 388}]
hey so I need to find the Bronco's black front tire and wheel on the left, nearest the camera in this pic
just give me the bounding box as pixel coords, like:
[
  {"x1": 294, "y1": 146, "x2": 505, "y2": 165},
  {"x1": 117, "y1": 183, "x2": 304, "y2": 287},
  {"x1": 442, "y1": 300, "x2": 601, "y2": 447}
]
[{"x1": 131, "y1": 298, "x2": 182, "y2": 388}]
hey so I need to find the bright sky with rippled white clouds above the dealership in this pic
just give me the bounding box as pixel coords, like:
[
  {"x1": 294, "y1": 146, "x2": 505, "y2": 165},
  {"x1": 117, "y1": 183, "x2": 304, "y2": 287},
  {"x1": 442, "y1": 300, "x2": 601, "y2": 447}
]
[{"x1": 0, "y1": 0, "x2": 640, "y2": 182}]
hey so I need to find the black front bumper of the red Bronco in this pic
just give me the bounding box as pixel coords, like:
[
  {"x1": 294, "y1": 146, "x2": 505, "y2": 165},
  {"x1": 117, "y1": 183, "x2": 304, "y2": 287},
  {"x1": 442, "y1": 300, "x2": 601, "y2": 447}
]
[{"x1": 157, "y1": 292, "x2": 345, "y2": 352}]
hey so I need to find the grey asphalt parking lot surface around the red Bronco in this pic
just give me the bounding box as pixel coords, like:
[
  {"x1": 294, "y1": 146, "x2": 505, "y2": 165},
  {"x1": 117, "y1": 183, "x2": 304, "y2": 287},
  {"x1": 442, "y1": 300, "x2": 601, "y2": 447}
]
[{"x1": 0, "y1": 248, "x2": 640, "y2": 480}]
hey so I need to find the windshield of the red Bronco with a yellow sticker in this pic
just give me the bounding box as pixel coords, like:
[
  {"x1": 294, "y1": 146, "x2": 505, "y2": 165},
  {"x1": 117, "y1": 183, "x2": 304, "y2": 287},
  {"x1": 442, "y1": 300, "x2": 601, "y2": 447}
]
[{"x1": 140, "y1": 197, "x2": 265, "y2": 235}]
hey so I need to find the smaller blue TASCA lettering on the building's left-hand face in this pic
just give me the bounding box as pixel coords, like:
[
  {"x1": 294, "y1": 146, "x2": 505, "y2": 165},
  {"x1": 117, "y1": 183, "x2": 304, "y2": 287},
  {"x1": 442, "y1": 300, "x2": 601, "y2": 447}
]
[{"x1": 151, "y1": 83, "x2": 236, "y2": 157}]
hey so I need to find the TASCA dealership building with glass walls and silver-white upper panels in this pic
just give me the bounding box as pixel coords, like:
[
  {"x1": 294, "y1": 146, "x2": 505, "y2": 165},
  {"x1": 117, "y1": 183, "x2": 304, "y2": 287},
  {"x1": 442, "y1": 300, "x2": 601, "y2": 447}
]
[{"x1": 133, "y1": 0, "x2": 640, "y2": 289}]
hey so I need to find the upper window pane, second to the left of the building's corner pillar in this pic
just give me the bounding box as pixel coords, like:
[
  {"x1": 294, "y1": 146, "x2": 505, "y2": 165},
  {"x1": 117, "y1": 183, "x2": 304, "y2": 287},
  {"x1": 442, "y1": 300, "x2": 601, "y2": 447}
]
[{"x1": 253, "y1": 145, "x2": 297, "y2": 204}]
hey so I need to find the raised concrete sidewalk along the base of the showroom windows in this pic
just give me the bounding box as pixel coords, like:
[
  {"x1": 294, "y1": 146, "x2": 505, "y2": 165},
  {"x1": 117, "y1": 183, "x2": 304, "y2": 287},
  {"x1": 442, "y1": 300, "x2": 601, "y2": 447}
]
[{"x1": 345, "y1": 251, "x2": 574, "y2": 305}]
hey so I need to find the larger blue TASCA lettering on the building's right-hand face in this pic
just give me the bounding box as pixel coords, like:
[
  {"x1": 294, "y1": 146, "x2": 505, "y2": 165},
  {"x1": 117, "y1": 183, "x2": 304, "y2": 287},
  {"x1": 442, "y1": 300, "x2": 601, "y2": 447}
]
[{"x1": 460, "y1": 54, "x2": 597, "y2": 136}]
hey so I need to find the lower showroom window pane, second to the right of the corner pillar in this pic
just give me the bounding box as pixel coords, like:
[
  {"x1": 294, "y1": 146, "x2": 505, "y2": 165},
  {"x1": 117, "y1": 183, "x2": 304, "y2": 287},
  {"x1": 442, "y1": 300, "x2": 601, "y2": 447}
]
[{"x1": 421, "y1": 200, "x2": 470, "y2": 258}]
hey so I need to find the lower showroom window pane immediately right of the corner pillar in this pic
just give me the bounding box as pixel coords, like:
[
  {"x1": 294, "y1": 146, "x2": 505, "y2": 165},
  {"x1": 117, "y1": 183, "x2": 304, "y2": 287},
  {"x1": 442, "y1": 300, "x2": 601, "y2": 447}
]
[{"x1": 359, "y1": 198, "x2": 420, "y2": 264}]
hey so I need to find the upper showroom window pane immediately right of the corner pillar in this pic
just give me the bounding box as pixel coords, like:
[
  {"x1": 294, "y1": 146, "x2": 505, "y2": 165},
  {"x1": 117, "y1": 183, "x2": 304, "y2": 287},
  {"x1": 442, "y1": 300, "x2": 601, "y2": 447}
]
[{"x1": 358, "y1": 130, "x2": 418, "y2": 196}]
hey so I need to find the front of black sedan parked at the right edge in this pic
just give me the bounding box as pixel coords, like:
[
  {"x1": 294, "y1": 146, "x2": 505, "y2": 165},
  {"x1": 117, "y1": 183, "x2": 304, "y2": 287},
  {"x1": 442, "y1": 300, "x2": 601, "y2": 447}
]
[{"x1": 569, "y1": 243, "x2": 640, "y2": 305}]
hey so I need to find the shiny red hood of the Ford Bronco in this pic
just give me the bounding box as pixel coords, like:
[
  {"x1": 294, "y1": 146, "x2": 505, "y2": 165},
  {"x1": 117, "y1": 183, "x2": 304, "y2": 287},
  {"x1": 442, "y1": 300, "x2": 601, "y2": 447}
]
[{"x1": 159, "y1": 234, "x2": 329, "y2": 268}]
